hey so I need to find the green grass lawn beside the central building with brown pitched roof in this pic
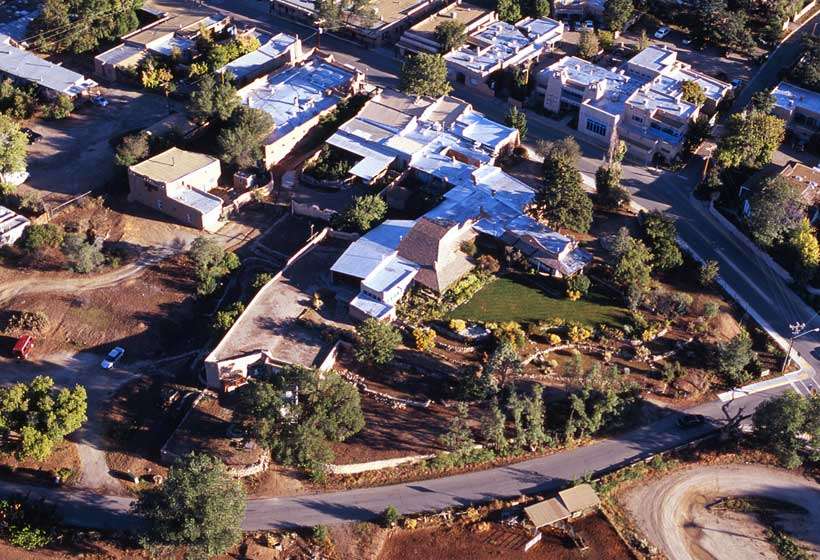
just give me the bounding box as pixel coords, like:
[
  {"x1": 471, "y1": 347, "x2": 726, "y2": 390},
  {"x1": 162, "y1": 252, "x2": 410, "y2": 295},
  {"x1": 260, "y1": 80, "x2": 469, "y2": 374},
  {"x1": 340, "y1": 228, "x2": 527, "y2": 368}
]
[{"x1": 450, "y1": 277, "x2": 627, "y2": 327}]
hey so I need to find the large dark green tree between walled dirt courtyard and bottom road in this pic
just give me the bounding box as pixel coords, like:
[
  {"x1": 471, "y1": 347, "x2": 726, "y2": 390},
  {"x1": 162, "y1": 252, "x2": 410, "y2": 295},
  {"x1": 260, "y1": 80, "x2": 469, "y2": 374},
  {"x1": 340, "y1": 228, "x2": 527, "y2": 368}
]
[{"x1": 242, "y1": 366, "x2": 364, "y2": 472}]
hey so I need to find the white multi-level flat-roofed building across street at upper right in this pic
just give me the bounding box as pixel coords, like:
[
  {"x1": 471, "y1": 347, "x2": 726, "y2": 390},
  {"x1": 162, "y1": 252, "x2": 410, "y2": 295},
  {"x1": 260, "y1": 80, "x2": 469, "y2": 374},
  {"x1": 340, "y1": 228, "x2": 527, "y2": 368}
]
[{"x1": 539, "y1": 46, "x2": 731, "y2": 164}]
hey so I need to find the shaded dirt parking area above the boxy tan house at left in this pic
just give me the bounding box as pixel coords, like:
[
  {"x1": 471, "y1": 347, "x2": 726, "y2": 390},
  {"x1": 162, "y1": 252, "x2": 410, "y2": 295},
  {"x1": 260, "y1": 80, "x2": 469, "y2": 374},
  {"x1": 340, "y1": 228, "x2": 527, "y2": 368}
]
[{"x1": 25, "y1": 87, "x2": 180, "y2": 201}]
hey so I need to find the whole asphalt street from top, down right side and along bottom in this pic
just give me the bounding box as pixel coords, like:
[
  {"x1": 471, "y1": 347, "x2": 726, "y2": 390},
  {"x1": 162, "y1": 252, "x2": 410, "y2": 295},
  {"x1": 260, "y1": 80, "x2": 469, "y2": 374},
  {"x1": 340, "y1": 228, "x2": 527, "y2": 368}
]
[{"x1": 0, "y1": 0, "x2": 820, "y2": 530}]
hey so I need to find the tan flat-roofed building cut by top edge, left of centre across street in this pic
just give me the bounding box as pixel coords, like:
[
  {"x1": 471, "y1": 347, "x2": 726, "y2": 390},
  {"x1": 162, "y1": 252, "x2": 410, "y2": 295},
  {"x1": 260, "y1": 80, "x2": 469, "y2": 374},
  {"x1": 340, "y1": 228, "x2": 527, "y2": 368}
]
[{"x1": 271, "y1": 0, "x2": 445, "y2": 47}]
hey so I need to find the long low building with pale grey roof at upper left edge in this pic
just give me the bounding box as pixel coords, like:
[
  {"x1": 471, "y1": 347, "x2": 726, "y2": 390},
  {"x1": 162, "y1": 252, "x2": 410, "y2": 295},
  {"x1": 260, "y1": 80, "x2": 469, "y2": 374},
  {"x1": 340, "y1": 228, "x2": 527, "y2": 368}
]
[{"x1": 0, "y1": 35, "x2": 97, "y2": 99}]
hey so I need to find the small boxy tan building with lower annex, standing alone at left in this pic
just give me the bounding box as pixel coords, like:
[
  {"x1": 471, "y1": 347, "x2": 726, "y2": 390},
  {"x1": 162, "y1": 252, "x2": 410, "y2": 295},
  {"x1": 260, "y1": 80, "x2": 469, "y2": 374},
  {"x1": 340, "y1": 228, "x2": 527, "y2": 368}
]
[{"x1": 128, "y1": 148, "x2": 223, "y2": 231}]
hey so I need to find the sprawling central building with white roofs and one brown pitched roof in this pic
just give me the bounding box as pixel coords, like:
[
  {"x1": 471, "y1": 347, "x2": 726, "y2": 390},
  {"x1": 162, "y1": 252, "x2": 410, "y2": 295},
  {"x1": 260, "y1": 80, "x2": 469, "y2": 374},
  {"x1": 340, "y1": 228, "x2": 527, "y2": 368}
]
[{"x1": 328, "y1": 91, "x2": 591, "y2": 320}]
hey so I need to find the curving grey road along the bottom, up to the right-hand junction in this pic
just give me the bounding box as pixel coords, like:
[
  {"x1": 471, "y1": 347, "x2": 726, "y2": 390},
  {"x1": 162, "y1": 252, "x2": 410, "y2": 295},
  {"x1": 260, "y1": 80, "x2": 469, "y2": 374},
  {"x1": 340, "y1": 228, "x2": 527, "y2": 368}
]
[{"x1": 0, "y1": 378, "x2": 782, "y2": 530}]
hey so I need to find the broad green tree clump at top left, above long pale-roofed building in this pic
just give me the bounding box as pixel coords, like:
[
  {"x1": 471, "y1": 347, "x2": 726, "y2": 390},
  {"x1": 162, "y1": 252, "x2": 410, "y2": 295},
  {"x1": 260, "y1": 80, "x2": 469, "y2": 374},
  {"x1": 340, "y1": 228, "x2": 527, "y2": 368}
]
[{"x1": 29, "y1": 0, "x2": 142, "y2": 53}]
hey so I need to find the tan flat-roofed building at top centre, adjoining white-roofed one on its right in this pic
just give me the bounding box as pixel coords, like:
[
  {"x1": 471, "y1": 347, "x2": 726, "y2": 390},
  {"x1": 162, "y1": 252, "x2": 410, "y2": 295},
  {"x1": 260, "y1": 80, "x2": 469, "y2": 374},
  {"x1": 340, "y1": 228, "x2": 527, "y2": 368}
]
[{"x1": 398, "y1": 0, "x2": 498, "y2": 56}]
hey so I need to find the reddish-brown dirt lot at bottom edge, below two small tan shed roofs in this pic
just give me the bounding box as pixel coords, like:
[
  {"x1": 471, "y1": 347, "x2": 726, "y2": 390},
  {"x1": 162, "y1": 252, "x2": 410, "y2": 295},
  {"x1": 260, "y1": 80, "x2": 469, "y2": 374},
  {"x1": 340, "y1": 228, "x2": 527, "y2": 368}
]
[{"x1": 378, "y1": 514, "x2": 634, "y2": 560}]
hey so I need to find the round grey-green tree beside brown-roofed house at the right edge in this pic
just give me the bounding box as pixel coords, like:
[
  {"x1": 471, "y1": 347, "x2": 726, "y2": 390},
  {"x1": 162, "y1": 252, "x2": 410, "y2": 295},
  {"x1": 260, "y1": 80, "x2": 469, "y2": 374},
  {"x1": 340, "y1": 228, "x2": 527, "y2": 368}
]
[{"x1": 747, "y1": 176, "x2": 806, "y2": 247}]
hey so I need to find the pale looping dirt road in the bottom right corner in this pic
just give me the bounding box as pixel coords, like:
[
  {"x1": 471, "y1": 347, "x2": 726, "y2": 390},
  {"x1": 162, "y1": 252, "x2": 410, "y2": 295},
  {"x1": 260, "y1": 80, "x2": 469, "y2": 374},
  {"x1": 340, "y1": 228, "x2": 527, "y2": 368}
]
[{"x1": 622, "y1": 465, "x2": 820, "y2": 560}]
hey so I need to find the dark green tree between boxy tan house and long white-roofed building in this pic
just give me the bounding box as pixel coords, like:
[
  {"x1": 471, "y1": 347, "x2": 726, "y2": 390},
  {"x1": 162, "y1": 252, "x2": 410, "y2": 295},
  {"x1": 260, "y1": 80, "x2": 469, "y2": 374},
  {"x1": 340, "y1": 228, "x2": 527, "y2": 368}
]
[{"x1": 217, "y1": 105, "x2": 274, "y2": 167}]
